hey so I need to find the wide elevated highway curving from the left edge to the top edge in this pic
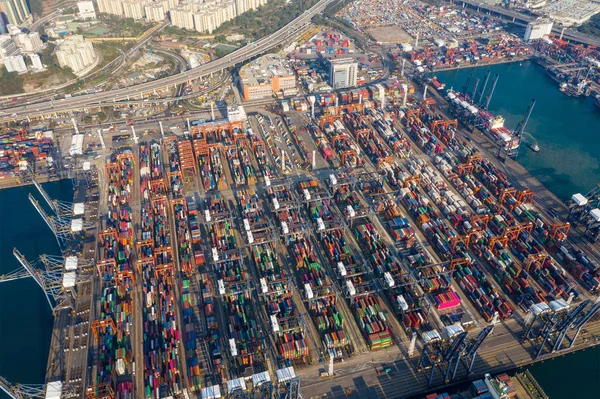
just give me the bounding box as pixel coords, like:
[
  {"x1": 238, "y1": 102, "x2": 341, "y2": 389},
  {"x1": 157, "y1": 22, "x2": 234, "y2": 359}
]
[{"x1": 0, "y1": 0, "x2": 334, "y2": 121}]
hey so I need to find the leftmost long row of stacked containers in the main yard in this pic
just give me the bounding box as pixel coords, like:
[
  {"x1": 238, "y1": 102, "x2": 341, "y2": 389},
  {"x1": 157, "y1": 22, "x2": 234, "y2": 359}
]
[{"x1": 91, "y1": 151, "x2": 135, "y2": 397}]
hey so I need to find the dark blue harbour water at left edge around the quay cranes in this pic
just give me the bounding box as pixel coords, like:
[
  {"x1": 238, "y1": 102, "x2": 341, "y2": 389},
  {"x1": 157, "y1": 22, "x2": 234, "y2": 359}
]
[{"x1": 0, "y1": 180, "x2": 73, "y2": 399}]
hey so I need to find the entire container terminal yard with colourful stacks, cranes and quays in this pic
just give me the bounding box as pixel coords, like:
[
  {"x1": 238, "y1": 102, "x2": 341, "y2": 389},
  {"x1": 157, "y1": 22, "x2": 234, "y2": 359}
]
[{"x1": 0, "y1": 75, "x2": 600, "y2": 399}]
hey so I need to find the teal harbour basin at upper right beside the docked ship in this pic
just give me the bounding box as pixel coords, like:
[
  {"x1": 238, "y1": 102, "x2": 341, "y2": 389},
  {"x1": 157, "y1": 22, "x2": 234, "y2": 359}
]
[{"x1": 436, "y1": 61, "x2": 600, "y2": 205}]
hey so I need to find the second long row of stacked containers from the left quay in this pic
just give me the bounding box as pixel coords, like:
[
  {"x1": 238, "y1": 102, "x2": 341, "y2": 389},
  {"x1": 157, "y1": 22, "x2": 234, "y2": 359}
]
[{"x1": 138, "y1": 143, "x2": 183, "y2": 398}]
